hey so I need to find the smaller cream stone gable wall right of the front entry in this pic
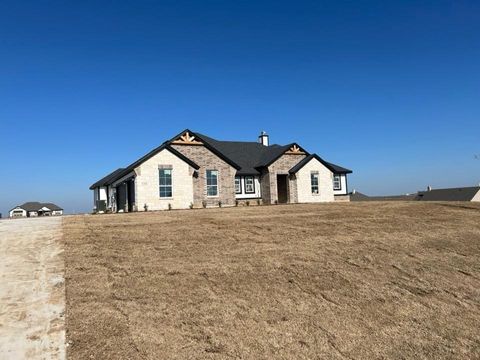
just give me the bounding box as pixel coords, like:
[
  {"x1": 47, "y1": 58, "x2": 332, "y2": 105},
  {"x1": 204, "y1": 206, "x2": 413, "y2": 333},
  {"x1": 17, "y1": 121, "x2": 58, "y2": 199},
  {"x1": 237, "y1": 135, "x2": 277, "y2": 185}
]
[{"x1": 296, "y1": 159, "x2": 334, "y2": 203}]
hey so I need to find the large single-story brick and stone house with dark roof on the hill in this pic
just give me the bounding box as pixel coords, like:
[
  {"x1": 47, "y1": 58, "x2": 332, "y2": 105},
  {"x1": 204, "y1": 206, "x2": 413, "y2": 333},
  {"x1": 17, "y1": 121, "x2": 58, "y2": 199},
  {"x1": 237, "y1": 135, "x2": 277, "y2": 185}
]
[{"x1": 90, "y1": 129, "x2": 352, "y2": 212}]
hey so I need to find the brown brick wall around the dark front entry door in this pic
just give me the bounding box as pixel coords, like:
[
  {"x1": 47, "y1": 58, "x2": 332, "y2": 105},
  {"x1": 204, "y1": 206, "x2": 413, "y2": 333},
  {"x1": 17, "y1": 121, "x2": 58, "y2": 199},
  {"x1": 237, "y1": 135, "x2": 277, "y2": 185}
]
[{"x1": 262, "y1": 154, "x2": 306, "y2": 204}]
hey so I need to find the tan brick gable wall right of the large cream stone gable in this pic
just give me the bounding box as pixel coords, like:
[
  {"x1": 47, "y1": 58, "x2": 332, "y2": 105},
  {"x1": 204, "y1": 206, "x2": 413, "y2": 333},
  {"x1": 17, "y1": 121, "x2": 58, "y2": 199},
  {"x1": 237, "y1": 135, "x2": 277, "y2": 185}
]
[{"x1": 172, "y1": 145, "x2": 237, "y2": 207}]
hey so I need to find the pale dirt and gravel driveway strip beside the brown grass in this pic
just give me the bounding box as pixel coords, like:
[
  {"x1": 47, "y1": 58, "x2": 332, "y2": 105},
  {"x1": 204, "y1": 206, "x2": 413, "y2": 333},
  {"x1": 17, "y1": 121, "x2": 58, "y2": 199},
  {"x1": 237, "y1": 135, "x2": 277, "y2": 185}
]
[{"x1": 0, "y1": 217, "x2": 65, "y2": 359}]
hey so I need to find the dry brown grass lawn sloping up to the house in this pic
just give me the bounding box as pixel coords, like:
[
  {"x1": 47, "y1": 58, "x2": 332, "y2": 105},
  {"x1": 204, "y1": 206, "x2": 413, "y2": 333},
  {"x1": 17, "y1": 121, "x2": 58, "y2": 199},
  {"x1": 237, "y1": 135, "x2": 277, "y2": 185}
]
[{"x1": 64, "y1": 202, "x2": 480, "y2": 359}]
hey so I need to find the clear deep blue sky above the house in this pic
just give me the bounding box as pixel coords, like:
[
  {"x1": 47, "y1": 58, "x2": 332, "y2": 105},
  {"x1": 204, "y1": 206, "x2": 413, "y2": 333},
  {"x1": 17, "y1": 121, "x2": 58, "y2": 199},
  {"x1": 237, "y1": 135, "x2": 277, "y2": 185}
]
[{"x1": 0, "y1": 1, "x2": 480, "y2": 214}]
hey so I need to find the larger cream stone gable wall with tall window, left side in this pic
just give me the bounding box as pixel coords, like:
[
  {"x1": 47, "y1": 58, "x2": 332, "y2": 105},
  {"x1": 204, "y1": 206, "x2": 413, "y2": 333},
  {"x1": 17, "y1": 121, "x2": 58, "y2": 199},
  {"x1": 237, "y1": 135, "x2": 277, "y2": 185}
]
[{"x1": 135, "y1": 149, "x2": 193, "y2": 211}]
